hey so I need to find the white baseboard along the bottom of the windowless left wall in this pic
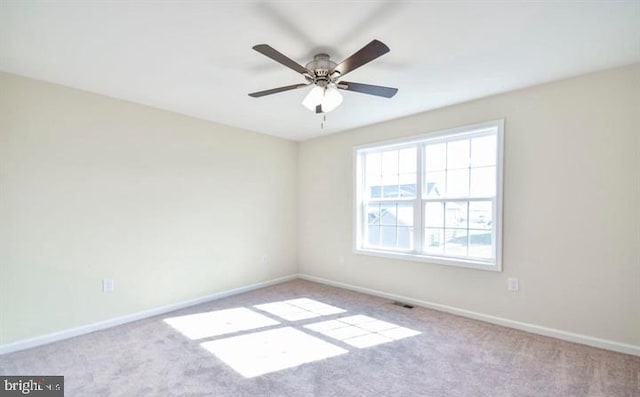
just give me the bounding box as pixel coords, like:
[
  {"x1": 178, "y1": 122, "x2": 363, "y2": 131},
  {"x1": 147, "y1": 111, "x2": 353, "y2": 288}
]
[{"x1": 0, "y1": 275, "x2": 297, "y2": 355}]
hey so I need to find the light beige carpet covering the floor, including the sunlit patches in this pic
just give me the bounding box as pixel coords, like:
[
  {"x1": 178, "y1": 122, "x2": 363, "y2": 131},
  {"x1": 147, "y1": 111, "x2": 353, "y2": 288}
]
[{"x1": 0, "y1": 280, "x2": 640, "y2": 397}]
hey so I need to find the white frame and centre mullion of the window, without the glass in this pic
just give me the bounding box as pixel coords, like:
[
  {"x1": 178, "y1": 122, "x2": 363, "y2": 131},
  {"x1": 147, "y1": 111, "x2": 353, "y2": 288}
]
[{"x1": 353, "y1": 119, "x2": 504, "y2": 272}]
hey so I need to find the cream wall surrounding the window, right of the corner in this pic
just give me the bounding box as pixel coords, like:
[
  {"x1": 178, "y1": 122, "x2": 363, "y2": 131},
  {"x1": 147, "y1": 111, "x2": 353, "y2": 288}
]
[{"x1": 298, "y1": 64, "x2": 640, "y2": 345}]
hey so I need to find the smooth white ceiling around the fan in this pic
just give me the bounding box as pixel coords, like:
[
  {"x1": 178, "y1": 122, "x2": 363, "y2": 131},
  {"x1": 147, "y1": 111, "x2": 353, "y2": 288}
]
[{"x1": 0, "y1": 0, "x2": 640, "y2": 140}]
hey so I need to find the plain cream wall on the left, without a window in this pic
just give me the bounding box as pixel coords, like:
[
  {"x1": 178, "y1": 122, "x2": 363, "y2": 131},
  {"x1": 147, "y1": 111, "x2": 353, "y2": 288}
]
[{"x1": 0, "y1": 74, "x2": 297, "y2": 344}]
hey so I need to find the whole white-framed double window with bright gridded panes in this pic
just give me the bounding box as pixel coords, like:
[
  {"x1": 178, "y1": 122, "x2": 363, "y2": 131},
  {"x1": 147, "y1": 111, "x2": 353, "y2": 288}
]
[{"x1": 354, "y1": 120, "x2": 504, "y2": 271}]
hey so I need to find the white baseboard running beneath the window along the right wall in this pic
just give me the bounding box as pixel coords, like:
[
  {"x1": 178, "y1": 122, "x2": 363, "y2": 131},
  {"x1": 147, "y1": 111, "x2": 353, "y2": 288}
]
[{"x1": 298, "y1": 274, "x2": 640, "y2": 356}]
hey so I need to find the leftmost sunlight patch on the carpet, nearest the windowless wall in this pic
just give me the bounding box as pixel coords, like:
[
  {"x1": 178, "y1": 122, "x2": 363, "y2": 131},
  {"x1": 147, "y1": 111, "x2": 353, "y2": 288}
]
[{"x1": 164, "y1": 307, "x2": 280, "y2": 339}]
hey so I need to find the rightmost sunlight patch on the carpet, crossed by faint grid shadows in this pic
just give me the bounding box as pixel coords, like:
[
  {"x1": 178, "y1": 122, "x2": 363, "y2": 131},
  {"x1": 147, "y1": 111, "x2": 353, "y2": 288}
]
[{"x1": 304, "y1": 315, "x2": 420, "y2": 349}]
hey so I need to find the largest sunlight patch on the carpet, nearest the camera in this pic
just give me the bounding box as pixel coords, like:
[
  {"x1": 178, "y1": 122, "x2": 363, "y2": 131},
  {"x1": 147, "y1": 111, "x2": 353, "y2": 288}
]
[{"x1": 201, "y1": 327, "x2": 348, "y2": 378}]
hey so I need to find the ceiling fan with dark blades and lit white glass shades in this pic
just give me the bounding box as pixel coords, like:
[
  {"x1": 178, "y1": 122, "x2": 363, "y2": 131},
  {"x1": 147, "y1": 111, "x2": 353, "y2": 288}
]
[{"x1": 249, "y1": 40, "x2": 398, "y2": 113}]
